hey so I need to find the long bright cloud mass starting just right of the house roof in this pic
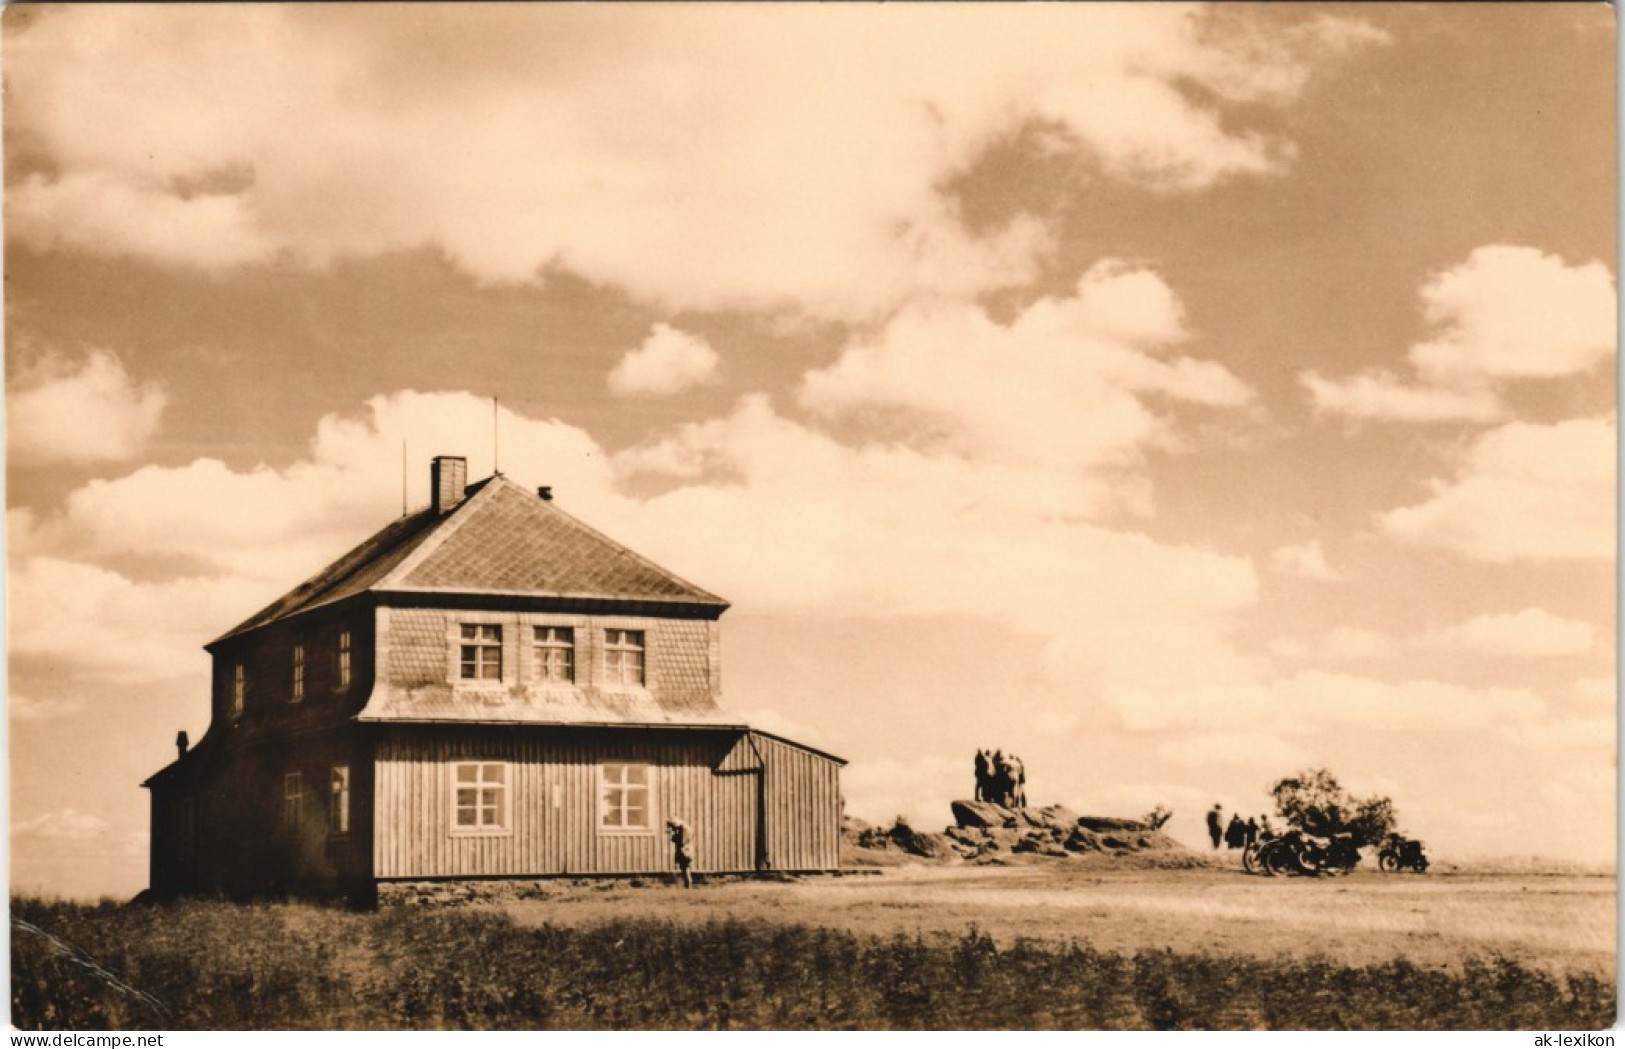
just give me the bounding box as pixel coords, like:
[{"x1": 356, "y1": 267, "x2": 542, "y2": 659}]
[{"x1": 618, "y1": 398, "x2": 1256, "y2": 643}]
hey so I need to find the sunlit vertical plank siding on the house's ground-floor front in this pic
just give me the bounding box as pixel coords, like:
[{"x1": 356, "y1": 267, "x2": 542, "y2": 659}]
[{"x1": 374, "y1": 726, "x2": 840, "y2": 878}]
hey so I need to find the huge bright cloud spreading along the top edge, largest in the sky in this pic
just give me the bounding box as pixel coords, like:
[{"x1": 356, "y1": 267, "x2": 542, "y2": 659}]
[{"x1": 7, "y1": 5, "x2": 1383, "y2": 317}]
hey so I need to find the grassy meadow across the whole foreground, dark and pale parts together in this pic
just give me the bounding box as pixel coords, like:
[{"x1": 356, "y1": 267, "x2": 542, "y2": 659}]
[{"x1": 11, "y1": 870, "x2": 1615, "y2": 1030}]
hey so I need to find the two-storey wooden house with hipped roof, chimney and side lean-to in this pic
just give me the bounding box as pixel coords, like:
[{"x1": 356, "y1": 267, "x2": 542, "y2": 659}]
[{"x1": 143, "y1": 456, "x2": 845, "y2": 898}]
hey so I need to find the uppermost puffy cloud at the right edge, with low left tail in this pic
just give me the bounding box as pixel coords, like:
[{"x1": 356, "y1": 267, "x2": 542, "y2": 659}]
[{"x1": 1298, "y1": 244, "x2": 1617, "y2": 422}]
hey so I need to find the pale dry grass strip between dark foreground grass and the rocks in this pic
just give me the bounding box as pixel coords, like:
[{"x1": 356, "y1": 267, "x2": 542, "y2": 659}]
[{"x1": 507, "y1": 866, "x2": 1615, "y2": 979}]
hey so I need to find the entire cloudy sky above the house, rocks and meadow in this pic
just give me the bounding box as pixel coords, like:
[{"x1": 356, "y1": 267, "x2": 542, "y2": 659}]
[{"x1": 0, "y1": 3, "x2": 1617, "y2": 895}]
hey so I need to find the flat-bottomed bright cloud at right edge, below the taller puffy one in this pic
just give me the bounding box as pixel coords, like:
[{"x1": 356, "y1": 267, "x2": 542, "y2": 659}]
[{"x1": 1378, "y1": 419, "x2": 1615, "y2": 562}]
